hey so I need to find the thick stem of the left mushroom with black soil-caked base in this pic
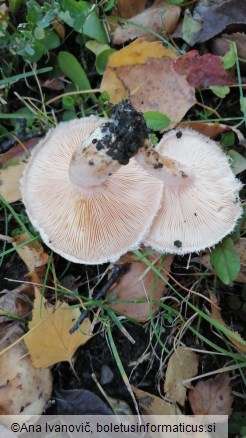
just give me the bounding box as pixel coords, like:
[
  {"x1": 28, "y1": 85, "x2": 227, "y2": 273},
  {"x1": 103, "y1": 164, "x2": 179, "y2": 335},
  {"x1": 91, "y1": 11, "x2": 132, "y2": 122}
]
[{"x1": 69, "y1": 102, "x2": 148, "y2": 187}]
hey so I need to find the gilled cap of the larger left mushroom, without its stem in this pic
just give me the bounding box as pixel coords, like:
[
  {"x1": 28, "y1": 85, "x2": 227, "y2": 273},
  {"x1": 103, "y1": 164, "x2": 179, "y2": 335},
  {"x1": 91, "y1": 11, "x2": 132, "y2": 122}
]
[{"x1": 21, "y1": 117, "x2": 162, "y2": 264}]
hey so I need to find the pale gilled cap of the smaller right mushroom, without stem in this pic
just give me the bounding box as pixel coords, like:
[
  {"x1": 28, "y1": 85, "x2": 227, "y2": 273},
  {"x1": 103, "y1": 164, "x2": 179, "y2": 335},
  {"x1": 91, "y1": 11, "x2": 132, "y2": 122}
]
[{"x1": 146, "y1": 129, "x2": 242, "y2": 254}]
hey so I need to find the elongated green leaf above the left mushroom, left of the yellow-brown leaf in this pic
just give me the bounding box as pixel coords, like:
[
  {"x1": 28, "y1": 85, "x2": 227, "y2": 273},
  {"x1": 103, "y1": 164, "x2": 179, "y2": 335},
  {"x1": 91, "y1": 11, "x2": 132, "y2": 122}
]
[{"x1": 58, "y1": 52, "x2": 91, "y2": 90}]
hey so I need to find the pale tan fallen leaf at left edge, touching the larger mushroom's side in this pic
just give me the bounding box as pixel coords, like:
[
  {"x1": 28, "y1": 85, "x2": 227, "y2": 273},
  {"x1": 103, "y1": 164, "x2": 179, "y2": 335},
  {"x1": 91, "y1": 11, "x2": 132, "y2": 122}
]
[{"x1": 0, "y1": 161, "x2": 25, "y2": 203}]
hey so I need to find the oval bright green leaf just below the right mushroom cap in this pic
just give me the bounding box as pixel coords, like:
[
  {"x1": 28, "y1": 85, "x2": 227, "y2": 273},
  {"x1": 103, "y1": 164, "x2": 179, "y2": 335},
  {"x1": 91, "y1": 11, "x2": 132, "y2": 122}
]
[{"x1": 210, "y1": 237, "x2": 240, "y2": 285}]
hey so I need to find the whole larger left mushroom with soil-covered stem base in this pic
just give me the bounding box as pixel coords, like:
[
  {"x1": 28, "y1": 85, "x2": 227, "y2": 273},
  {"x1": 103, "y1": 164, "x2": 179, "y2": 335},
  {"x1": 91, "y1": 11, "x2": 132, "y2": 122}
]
[{"x1": 21, "y1": 104, "x2": 162, "y2": 264}]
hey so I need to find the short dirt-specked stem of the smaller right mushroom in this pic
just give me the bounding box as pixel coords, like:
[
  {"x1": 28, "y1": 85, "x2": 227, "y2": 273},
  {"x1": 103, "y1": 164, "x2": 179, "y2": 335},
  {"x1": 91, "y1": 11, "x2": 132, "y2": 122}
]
[{"x1": 135, "y1": 140, "x2": 194, "y2": 187}]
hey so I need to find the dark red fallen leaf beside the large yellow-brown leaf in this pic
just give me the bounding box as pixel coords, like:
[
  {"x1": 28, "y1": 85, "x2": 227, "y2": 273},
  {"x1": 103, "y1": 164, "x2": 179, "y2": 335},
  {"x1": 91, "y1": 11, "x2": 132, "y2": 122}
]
[{"x1": 173, "y1": 50, "x2": 235, "y2": 88}]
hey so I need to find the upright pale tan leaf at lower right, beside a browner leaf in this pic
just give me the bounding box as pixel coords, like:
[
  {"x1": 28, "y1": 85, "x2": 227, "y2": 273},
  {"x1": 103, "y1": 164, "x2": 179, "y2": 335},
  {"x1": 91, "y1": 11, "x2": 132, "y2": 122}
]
[{"x1": 164, "y1": 347, "x2": 199, "y2": 406}]
